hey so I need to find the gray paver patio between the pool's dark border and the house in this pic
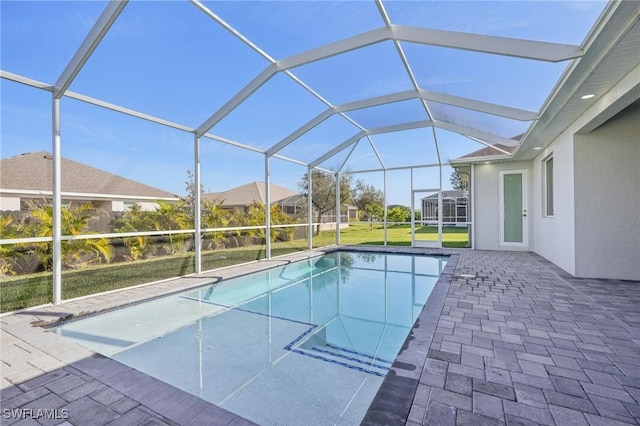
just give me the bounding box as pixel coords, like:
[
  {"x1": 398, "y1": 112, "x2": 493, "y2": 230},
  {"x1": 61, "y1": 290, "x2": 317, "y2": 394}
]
[{"x1": 409, "y1": 252, "x2": 640, "y2": 426}]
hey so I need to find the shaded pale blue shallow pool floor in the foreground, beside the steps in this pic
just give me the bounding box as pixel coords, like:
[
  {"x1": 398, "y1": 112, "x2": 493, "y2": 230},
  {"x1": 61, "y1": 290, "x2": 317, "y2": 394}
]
[{"x1": 112, "y1": 310, "x2": 383, "y2": 425}]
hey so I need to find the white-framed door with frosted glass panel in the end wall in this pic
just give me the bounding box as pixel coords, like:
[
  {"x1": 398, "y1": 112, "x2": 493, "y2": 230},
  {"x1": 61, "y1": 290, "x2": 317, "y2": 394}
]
[{"x1": 499, "y1": 170, "x2": 529, "y2": 247}]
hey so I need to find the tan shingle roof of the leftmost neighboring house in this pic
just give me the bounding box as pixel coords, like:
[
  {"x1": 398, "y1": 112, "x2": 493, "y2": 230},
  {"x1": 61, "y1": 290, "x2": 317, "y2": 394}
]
[{"x1": 0, "y1": 151, "x2": 176, "y2": 198}]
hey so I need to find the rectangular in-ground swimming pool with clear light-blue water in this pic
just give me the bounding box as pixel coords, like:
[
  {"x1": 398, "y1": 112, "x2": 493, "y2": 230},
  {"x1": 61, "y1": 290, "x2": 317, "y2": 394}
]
[{"x1": 54, "y1": 252, "x2": 447, "y2": 425}]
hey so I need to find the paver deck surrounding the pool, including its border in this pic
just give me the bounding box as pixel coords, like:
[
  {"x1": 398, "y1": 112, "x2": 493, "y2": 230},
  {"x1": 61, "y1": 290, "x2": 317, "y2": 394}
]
[{"x1": 0, "y1": 246, "x2": 640, "y2": 426}]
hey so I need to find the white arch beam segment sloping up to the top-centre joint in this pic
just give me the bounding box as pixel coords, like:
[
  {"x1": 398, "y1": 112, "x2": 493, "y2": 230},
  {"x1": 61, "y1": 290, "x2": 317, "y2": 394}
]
[{"x1": 277, "y1": 27, "x2": 393, "y2": 70}]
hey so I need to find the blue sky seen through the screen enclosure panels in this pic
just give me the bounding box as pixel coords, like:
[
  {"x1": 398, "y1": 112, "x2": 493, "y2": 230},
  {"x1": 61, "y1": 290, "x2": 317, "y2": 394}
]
[{"x1": 0, "y1": 0, "x2": 604, "y2": 205}]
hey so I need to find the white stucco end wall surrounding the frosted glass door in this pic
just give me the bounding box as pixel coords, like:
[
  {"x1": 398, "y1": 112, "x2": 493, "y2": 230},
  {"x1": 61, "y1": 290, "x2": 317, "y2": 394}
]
[{"x1": 472, "y1": 161, "x2": 534, "y2": 250}]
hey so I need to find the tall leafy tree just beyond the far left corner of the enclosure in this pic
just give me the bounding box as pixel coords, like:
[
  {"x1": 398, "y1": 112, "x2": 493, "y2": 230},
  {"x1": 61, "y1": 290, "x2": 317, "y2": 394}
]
[{"x1": 298, "y1": 170, "x2": 351, "y2": 235}]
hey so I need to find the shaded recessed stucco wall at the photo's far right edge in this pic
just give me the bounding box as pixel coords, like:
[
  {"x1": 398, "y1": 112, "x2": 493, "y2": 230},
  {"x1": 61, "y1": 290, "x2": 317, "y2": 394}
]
[{"x1": 574, "y1": 107, "x2": 640, "y2": 280}]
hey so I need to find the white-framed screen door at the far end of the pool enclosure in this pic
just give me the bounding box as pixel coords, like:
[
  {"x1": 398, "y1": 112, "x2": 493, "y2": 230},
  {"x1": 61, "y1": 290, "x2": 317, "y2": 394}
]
[{"x1": 411, "y1": 189, "x2": 442, "y2": 248}]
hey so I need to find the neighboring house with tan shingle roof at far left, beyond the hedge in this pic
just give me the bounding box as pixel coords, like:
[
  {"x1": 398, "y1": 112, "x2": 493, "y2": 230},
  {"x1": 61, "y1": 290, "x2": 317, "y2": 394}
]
[{"x1": 0, "y1": 151, "x2": 178, "y2": 213}]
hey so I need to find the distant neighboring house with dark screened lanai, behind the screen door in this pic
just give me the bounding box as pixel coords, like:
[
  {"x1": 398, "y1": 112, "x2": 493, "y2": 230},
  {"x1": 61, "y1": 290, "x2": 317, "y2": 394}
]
[{"x1": 422, "y1": 189, "x2": 469, "y2": 226}]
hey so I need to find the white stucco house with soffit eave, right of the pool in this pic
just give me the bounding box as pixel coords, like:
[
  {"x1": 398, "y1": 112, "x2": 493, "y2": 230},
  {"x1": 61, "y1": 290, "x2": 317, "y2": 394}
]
[{"x1": 450, "y1": 15, "x2": 640, "y2": 280}]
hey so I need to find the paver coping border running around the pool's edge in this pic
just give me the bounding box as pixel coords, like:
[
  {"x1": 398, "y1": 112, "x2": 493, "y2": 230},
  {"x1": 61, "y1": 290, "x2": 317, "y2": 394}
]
[{"x1": 1, "y1": 245, "x2": 458, "y2": 425}]
